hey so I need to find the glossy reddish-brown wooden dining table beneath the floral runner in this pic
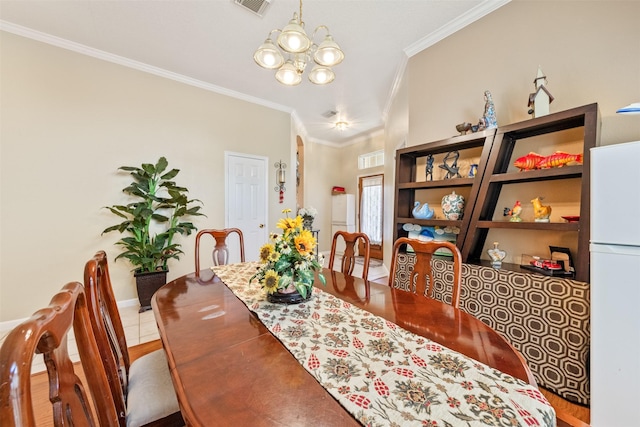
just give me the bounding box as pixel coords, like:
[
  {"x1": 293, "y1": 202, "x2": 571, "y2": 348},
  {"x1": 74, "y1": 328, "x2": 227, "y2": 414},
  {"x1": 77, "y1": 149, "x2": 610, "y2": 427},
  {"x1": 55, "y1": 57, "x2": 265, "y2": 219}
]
[{"x1": 151, "y1": 269, "x2": 535, "y2": 426}]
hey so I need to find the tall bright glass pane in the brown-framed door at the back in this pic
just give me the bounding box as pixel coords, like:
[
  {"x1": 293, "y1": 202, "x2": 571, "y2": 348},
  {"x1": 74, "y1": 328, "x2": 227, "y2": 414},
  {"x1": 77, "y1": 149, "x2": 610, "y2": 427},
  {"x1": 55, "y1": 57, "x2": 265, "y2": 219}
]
[{"x1": 360, "y1": 175, "x2": 383, "y2": 246}]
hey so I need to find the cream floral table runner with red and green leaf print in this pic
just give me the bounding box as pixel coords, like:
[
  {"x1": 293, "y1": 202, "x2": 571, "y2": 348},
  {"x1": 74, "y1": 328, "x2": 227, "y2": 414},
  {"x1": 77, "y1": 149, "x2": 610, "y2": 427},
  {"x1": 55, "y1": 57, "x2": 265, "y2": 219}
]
[{"x1": 213, "y1": 263, "x2": 556, "y2": 427}]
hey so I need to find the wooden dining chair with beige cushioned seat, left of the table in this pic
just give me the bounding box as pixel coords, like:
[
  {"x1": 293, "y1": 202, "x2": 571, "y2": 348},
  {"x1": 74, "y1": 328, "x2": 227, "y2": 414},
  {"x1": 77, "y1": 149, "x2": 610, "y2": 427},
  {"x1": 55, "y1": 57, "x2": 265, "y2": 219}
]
[{"x1": 84, "y1": 251, "x2": 184, "y2": 426}]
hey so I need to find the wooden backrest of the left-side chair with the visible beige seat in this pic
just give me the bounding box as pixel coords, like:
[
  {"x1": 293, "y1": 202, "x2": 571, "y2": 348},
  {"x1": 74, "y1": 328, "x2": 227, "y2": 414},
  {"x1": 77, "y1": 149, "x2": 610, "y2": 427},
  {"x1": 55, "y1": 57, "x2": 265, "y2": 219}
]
[{"x1": 84, "y1": 251, "x2": 130, "y2": 426}]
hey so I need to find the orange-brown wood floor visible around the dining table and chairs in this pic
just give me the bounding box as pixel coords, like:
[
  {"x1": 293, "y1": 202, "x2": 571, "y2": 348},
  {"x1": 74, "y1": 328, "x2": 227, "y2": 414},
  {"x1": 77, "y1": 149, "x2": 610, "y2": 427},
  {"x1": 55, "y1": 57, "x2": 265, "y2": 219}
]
[{"x1": 26, "y1": 340, "x2": 590, "y2": 427}]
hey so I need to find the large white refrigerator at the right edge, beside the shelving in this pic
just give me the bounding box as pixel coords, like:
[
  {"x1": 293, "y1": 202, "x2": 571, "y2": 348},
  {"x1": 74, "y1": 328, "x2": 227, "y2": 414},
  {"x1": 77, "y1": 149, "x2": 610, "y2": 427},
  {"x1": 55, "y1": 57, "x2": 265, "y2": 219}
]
[{"x1": 590, "y1": 141, "x2": 640, "y2": 427}]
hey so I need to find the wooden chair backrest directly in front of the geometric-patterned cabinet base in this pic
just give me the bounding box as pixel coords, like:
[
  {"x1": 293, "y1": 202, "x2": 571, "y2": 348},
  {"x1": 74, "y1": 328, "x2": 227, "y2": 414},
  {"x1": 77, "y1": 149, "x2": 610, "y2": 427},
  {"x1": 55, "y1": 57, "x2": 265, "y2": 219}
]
[{"x1": 389, "y1": 237, "x2": 462, "y2": 308}]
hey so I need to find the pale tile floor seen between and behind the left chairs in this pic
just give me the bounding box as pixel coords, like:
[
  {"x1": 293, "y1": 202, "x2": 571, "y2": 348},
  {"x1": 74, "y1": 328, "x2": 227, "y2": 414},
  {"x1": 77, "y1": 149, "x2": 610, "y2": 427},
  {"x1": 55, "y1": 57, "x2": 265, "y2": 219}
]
[{"x1": 0, "y1": 301, "x2": 160, "y2": 374}]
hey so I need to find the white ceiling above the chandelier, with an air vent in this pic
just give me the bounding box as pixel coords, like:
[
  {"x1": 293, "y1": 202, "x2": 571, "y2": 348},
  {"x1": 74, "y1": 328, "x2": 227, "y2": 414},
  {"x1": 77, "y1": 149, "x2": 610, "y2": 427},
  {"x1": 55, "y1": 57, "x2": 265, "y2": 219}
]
[{"x1": 0, "y1": 0, "x2": 510, "y2": 145}]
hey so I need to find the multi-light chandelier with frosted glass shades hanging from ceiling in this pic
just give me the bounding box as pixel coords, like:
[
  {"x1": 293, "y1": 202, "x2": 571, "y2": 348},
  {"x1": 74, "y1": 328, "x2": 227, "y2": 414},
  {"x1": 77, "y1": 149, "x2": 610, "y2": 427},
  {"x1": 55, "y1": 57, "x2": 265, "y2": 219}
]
[{"x1": 253, "y1": 0, "x2": 344, "y2": 86}]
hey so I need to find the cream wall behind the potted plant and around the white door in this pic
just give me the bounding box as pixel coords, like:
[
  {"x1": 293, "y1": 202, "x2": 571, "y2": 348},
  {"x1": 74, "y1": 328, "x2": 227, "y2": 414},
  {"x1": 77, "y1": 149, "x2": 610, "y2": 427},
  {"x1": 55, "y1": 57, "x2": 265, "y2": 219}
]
[{"x1": 0, "y1": 33, "x2": 295, "y2": 322}]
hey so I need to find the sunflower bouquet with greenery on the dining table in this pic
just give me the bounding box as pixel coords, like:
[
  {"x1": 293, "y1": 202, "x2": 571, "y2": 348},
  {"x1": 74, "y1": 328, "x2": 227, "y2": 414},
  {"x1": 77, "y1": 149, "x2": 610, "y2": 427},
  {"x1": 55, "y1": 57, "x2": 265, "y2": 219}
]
[{"x1": 249, "y1": 209, "x2": 326, "y2": 299}]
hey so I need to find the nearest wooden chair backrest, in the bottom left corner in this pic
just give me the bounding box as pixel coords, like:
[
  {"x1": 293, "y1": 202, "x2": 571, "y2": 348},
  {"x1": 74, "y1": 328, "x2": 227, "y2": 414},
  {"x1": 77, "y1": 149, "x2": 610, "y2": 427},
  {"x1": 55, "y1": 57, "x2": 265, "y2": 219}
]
[{"x1": 0, "y1": 282, "x2": 117, "y2": 427}]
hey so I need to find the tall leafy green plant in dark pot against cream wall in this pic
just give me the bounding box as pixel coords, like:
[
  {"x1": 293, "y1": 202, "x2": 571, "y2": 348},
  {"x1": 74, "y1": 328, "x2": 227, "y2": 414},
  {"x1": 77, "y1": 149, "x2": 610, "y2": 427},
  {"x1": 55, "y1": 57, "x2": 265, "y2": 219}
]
[{"x1": 102, "y1": 157, "x2": 203, "y2": 311}]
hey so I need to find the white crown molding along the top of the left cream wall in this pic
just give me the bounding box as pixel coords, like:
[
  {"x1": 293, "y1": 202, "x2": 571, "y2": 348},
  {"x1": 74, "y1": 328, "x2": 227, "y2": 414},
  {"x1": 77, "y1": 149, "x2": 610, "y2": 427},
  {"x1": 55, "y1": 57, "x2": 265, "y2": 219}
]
[{"x1": 0, "y1": 20, "x2": 292, "y2": 114}]
